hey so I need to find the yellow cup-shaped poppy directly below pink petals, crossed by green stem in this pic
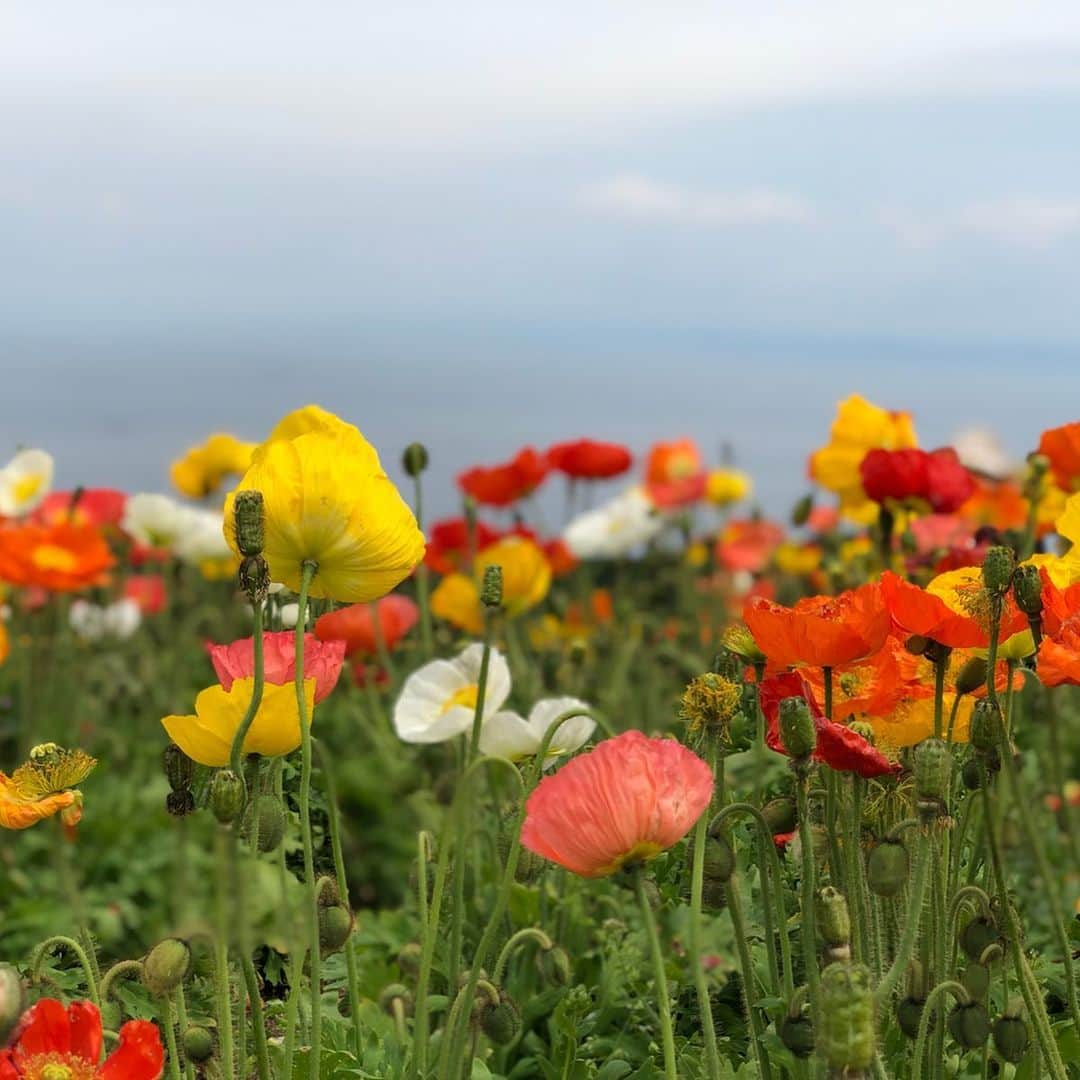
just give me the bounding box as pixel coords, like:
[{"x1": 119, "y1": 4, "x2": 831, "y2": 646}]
[{"x1": 161, "y1": 678, "x2": 315, "y2": 768}]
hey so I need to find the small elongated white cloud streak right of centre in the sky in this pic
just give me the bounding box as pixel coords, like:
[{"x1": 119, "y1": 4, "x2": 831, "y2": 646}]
[{"x1": 580, "y1": 173, "x2": 814, "y2": 228}]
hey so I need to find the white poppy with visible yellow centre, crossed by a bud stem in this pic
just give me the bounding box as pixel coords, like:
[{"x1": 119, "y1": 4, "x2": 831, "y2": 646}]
[{"x1": 394, "y1": 645, "x2": 510, "y2": 743}]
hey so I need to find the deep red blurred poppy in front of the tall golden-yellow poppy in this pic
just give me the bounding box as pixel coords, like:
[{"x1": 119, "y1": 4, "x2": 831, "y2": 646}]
[{"x1": 859, "y1": 447, "x2": 975, "y2": 514}]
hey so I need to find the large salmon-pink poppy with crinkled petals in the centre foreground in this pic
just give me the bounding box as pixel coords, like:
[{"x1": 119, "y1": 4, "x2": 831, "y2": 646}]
[{"x1": 522, "y1": 731, "x2": 713, "y2": 877}]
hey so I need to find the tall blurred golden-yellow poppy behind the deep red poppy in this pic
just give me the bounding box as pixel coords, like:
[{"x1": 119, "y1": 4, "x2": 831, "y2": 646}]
[{"x1": 810, "y1": 394, "x2": 919, "y2": 523}]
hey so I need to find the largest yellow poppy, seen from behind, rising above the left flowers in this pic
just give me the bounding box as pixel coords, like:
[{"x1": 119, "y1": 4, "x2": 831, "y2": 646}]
[{"x1": 225, "y1": 406, "x2": 424, "y2": 604}]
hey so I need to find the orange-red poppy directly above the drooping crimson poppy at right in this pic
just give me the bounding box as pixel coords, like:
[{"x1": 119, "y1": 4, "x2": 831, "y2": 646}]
[{"x1": 743, "y1": 584, "x2": 891, "y2": 667}]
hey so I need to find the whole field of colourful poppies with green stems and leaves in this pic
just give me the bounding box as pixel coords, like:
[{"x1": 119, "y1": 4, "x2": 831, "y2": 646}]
[{"x1": 0, "y1": 395, "x2": 1080, "y2": 1080}]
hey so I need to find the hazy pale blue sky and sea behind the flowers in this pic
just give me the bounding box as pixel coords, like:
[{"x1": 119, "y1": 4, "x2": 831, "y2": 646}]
[{"x1": 0, "y1": 0, "x2": 1080, "y2": 518}]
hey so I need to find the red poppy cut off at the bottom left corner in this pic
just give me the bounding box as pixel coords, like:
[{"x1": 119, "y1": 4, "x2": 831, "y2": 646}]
[{"x1": 0, "y1": 998, "x2": 165, "y2": 1080}]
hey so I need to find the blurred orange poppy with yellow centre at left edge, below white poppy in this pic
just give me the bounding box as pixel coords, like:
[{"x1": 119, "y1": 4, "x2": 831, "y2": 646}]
[{"x1": 0, "y1": 522, "x2": 116, "y2": 593}]
